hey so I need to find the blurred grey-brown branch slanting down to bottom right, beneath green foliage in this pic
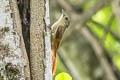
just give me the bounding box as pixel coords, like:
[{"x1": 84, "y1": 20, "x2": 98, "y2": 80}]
[{"x1": 80, "y1": 27, "x2": 117, "y2": 80}]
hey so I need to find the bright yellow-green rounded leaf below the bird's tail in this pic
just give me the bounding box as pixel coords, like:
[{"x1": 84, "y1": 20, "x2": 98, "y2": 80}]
[{"x1": 55, "y1": 72, "x2": 72, "y2": 80}]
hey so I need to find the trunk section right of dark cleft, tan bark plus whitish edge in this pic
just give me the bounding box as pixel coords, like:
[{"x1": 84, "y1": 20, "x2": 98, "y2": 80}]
[{"x1": 30, "y1": 0, "x2": 52, "y2": 80}]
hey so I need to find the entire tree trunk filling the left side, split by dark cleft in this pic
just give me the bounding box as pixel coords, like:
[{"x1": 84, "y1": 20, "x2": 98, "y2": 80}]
[{"x1": 0, "y1": 0, "x2": 52, "y2": 80}]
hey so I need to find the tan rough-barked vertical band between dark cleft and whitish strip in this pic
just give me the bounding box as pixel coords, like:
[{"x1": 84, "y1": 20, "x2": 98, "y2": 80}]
[{"x1": 30, "y1": 0, "x2": 45, "y2": 80}]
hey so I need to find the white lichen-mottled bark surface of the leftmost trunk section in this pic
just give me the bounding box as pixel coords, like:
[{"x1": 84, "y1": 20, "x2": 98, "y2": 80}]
[{"x1": 0, "y1": 0, "x2": 25, "y2": 80}]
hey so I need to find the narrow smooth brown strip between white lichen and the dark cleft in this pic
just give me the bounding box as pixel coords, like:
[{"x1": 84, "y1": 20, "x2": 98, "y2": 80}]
[{"x1": 10, "y1": 0, "x2": 30, "y2": 80}]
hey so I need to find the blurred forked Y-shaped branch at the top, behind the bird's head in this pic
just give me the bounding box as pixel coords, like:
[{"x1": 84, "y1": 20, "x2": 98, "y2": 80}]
[{"x1": 57, "y1": 0, "x2": 112, "y2": 37}]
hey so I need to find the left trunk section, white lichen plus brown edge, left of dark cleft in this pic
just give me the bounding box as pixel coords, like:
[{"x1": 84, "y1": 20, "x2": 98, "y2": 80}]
[{"x1": 0, "y1": 0, "x2": 30, "y2": 80}]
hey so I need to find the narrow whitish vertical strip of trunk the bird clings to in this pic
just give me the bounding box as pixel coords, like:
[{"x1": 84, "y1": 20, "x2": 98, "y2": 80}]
[{"x1": 44, "y1": 0, "x2": 52, "y2": 80}]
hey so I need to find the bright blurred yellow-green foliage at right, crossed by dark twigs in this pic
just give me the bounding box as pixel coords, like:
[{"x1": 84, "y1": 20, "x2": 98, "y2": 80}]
[{"x1": 87, "y1": 5, "x2": 120, "y2": 69}]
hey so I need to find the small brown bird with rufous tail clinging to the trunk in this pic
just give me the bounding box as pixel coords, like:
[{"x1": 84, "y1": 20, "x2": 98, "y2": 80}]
[{"x1": 51, "y1": 12, "x2": 69, "y2": 75}]
